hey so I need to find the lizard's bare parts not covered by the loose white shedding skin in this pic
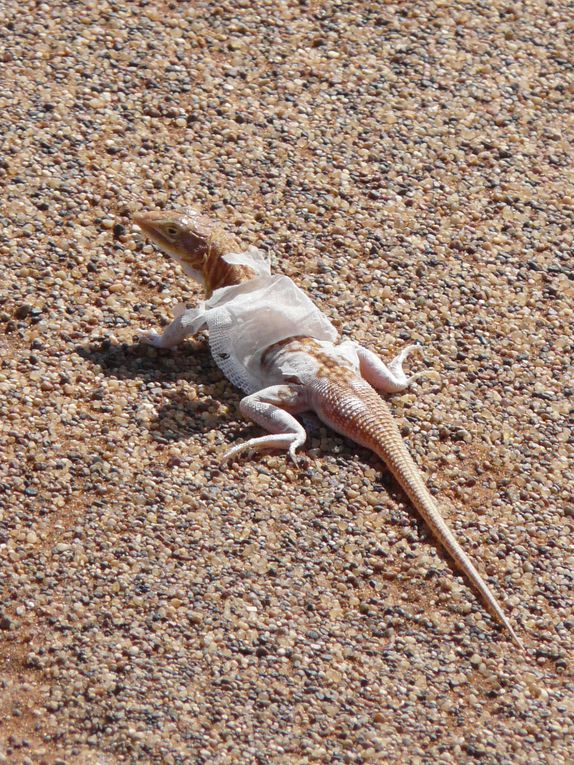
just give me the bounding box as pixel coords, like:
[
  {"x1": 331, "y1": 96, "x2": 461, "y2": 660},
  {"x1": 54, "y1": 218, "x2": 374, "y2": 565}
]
[{"x1": 135, "y1": 207, "x2": 523, "y2": 648}]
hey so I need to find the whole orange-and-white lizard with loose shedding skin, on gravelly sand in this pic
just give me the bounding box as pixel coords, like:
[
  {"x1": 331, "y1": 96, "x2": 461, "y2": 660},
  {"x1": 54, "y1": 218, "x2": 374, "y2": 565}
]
[{"x1": 134, "y1": 209, "x2": 524, "y2": 648}]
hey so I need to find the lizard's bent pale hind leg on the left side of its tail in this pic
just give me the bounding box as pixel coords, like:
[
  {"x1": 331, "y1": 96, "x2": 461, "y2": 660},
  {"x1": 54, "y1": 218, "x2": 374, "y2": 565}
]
[{"x1": 223, "y1": 385, "x2": 309, "y2": 463}]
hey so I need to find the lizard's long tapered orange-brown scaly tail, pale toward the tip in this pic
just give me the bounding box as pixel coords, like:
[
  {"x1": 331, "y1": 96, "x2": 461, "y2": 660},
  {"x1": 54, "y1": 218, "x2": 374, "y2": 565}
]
[{"x1": 317, "y1": 380, "x2": 524, "y2": 648}]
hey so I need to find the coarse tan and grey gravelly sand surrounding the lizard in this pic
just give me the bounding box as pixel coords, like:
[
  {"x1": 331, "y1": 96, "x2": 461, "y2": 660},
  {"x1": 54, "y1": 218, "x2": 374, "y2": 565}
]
[{"x1": 0, "y1": 0, "x2": 574, "y2": 765}]
